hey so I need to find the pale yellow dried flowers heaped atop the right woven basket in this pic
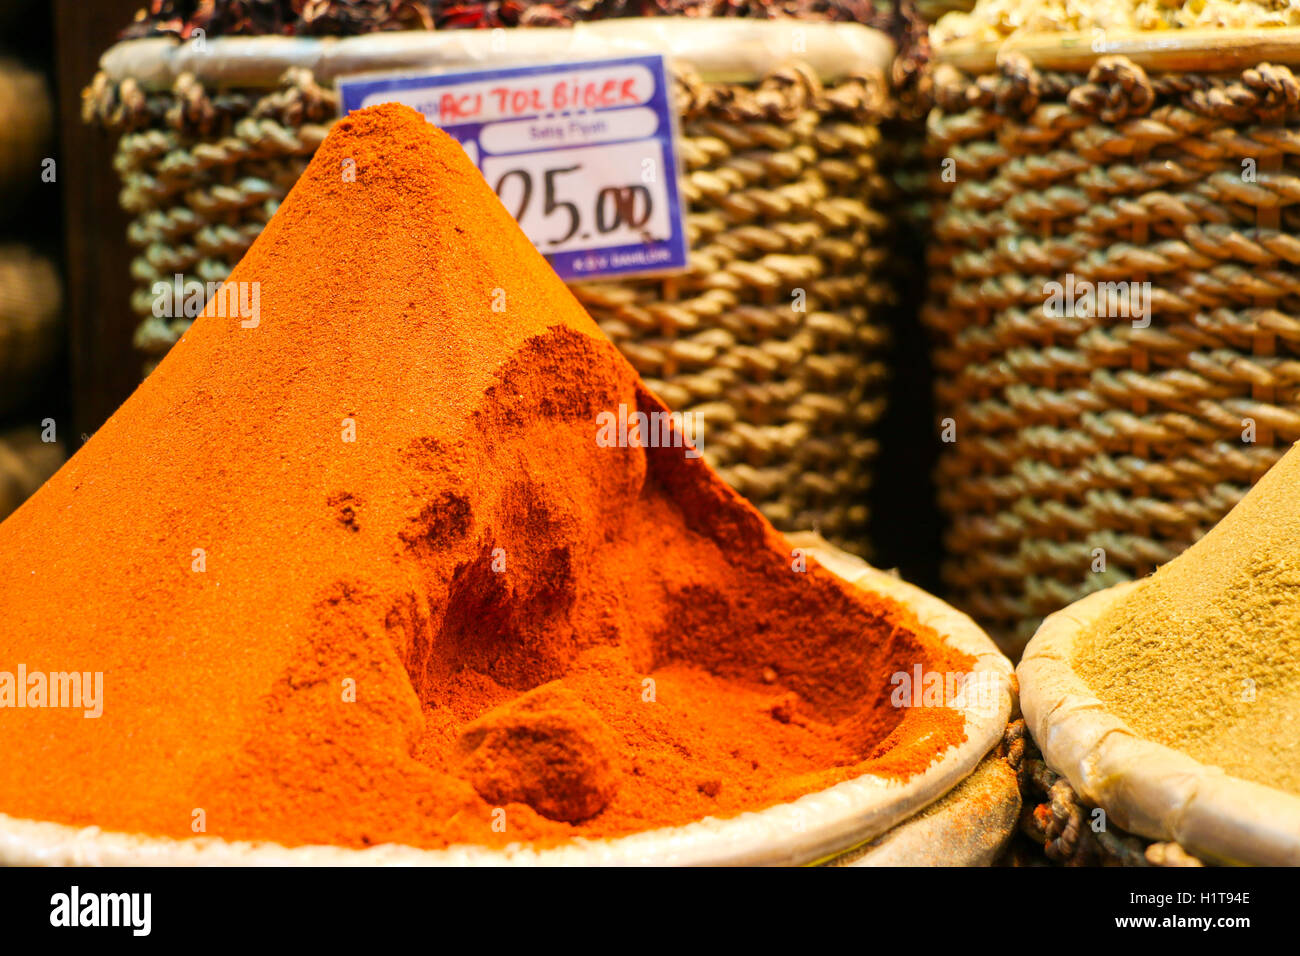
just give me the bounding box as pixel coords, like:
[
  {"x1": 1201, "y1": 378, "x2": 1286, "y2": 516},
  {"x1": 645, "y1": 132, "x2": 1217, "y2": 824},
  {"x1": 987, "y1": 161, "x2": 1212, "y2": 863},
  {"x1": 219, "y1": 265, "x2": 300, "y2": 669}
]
[{"x1": 931, "y1": 0, "x2": 1300, "y2": 46}]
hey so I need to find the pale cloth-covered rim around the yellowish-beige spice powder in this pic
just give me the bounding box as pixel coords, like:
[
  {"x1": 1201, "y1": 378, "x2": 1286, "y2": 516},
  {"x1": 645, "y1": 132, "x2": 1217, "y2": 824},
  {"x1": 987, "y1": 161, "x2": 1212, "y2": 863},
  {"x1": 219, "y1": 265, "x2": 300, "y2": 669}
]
[{"x1": 1015, "y1": 581, "x2": 1300, "y2": 866}]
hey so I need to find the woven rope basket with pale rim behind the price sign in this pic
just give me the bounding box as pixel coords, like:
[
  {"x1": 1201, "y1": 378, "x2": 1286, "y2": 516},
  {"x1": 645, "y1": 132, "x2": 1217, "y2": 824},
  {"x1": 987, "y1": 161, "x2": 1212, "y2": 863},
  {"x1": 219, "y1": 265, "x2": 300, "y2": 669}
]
[{"x1": 85, "y1": 20, "x2": 892, "y2": 553}]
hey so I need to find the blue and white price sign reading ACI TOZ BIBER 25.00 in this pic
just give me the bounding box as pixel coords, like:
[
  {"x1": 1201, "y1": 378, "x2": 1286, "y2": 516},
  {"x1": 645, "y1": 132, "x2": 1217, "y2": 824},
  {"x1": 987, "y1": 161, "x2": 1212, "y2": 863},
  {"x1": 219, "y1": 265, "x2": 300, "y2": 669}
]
[{"x1": 338, "y1": 55, "x2": 686, "y2": 280}]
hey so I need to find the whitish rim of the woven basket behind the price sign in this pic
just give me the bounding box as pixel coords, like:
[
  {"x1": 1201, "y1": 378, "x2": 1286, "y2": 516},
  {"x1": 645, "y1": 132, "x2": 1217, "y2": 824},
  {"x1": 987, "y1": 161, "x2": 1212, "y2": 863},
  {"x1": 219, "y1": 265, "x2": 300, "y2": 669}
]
[{"x1": 99, "y1": 17, "x2": 894, "y2": 91}]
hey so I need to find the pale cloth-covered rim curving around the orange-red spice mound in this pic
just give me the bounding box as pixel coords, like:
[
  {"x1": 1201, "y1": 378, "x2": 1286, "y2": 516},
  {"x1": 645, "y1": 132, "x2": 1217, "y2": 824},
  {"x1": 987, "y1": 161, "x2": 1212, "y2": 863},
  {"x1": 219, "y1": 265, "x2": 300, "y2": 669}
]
[{"x1": 0, "y1": 533, "x2": 1014, "y2": 866}]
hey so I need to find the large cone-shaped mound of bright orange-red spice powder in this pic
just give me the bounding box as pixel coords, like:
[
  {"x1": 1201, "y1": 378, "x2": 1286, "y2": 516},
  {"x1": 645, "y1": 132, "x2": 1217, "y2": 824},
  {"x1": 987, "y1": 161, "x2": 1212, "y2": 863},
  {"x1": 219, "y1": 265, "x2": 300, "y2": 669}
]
[{"x1": 0, "y1": 105, "x2": 971, "y2": 848}]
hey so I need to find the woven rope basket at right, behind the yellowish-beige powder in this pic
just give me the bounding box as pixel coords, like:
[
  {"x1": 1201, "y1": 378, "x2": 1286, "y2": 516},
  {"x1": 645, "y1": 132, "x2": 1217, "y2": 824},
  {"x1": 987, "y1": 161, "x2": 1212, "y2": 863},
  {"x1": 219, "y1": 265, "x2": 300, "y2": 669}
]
[{"x1": 923, "y1": 29, "x2": 1300, "y2": 657}]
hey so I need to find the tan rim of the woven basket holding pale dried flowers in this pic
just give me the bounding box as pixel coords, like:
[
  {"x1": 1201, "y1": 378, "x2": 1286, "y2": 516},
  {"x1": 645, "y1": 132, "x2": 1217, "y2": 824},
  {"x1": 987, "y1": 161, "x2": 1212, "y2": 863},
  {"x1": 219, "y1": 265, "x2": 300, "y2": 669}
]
[{"x1": 935, "y1": 26, "x2": 1300, "y2": 73}]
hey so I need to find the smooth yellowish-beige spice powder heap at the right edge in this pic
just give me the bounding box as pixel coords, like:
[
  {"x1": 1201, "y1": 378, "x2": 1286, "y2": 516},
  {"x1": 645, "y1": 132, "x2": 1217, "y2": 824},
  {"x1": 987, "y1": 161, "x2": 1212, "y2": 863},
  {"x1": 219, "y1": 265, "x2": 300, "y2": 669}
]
[{"x1": 1074, "y1": 447, "x2": 1300, "y2": 793}]
